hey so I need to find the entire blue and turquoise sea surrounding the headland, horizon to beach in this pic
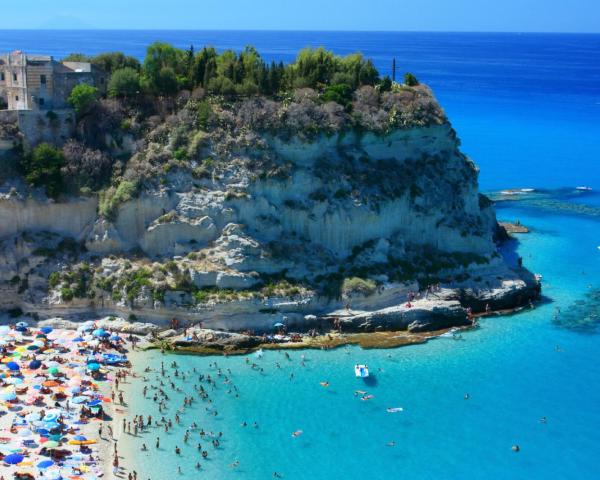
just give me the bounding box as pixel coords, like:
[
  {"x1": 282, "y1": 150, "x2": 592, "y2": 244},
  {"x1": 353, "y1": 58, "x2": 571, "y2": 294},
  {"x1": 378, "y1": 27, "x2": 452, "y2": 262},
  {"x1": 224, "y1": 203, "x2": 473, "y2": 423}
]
[{"x1": 0, "y1": 30, "x2": 600, "y2": 480}]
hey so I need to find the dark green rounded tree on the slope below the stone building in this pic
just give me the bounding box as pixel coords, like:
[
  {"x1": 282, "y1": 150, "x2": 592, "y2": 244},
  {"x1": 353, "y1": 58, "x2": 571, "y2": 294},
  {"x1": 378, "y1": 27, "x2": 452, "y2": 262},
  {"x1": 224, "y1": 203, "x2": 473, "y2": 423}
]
[{"x1": 21, "y1": 143, "x2": 65, "y2": 198}]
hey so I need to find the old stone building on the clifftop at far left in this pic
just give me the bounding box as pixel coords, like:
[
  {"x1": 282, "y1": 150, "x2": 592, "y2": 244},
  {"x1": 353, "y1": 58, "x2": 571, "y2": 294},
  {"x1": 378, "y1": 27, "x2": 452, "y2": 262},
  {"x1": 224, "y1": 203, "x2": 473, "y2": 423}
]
[{"x1": 0, "y1": 51, "x2": 107, "y2": 110}]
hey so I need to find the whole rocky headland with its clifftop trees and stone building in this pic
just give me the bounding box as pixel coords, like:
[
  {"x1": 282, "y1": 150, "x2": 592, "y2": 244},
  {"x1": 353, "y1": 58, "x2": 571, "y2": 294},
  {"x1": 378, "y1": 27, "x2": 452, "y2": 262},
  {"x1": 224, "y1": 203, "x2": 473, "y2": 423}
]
[{"x1": 0, "y1": 43, "x2": 541, "y2": 349}]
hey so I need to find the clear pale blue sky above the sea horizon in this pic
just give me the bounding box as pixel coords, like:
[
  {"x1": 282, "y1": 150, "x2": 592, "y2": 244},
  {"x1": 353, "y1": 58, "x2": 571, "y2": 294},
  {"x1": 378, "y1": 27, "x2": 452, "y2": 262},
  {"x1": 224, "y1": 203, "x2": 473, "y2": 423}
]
[{"x1": 0, "y1": 0, "x2": 600, "y2": 32}]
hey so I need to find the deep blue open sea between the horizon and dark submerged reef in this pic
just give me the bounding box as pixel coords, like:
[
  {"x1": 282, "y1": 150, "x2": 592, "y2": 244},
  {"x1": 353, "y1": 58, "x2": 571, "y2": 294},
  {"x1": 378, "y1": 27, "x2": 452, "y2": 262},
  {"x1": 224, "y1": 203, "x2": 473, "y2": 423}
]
[{"x1": 0, "y1": 30, "x2": 600, "y2": 190}]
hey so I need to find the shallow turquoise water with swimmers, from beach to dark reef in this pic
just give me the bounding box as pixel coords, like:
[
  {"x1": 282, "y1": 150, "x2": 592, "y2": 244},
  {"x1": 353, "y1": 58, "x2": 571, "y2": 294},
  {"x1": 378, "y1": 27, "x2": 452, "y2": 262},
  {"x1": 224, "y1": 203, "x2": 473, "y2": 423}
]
[{"x1": 120, "y1": 192, "x2": 600, "y2": 480}]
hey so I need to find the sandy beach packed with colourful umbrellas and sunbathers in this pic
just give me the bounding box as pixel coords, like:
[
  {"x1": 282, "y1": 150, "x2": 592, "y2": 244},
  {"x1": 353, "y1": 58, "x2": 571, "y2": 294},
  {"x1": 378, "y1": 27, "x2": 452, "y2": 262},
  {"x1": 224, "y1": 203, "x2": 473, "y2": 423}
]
[{"x1": 0, "y1": 322, "x2": 133, "y2": 480}]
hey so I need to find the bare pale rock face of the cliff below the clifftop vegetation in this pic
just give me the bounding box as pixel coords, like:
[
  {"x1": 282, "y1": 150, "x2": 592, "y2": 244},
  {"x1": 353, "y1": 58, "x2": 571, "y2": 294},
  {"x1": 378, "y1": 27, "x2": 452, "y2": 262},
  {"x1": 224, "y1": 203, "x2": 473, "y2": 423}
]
[{"x1": 0, "y1": 84, "x2": 538, "y2": 329}]
